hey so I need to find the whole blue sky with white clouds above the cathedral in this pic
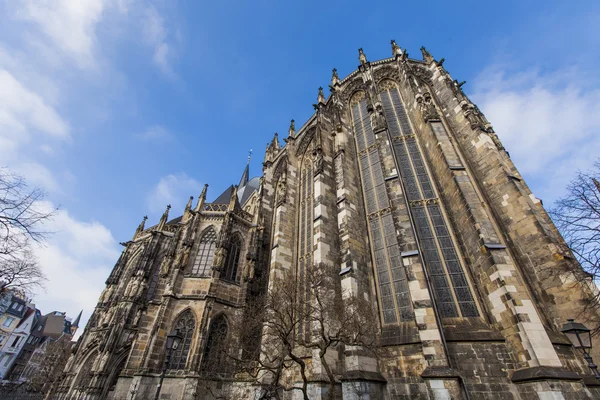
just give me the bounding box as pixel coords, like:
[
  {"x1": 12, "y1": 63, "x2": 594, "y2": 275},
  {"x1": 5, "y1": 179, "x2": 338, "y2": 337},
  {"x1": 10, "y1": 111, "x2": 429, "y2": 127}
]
[{"x1": 0, "y1": 0, "x2": 600, "y2": 332}]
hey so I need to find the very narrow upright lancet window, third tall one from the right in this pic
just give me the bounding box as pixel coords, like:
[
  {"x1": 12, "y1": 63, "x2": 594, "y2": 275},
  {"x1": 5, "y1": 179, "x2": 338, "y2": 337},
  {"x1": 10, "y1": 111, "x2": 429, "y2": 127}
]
[{"x1": 297, "y1": 141, "x2": 314, "y2": 340}]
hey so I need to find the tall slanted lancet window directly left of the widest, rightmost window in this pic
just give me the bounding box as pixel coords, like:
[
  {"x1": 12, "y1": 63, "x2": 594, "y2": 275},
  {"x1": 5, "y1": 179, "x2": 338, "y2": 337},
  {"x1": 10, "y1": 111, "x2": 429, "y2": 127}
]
[{"x1": 351, "y1": 92, "x2": 413, "y2": 324}]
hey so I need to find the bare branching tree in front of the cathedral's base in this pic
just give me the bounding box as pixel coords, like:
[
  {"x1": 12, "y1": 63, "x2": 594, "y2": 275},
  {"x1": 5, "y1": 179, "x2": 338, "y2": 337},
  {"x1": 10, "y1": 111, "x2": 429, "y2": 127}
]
[{"x1": 228, "y1": 264, "x2": 383, "y2": 400}]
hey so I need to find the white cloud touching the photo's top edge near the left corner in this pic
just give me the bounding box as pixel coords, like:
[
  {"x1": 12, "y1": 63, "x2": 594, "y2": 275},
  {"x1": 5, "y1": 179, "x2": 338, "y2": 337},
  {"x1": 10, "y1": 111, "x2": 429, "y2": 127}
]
[{"x1": 16, "y1": 0, "x2": 105, "y2": 67}]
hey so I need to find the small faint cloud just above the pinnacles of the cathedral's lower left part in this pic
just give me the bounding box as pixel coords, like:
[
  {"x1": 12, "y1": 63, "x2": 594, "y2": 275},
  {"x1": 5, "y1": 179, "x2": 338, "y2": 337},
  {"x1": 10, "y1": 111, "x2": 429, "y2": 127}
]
[{"x1": 147, "y1": 173, "x2": 202, "y2": 214}]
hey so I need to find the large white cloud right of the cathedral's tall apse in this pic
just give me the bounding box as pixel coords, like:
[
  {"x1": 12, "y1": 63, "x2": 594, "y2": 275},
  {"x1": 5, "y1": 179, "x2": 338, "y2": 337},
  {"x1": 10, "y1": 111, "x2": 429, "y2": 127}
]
[{"x1": 472, "y1": 66, "x2": 600, "y2": 205}]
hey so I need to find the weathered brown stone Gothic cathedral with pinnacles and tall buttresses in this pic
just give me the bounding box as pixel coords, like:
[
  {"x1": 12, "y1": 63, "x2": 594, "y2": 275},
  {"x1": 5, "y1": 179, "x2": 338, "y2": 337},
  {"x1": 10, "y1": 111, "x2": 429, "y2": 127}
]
[{"x1": 49, "y1": 41, "x2": 600, "y2": 400}]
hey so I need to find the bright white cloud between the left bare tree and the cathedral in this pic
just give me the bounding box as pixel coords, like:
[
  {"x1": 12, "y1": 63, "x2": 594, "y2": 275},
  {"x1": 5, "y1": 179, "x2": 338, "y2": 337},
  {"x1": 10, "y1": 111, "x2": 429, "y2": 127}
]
[{"x1": 35, "y1": 203, "x2": 119, "y2": 334}]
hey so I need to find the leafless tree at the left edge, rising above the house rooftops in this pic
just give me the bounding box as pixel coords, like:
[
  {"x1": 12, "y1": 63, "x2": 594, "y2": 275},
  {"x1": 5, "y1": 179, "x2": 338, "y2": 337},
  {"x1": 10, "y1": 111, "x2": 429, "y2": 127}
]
[{"x1": 0, "y1": 168, "x2": 55, "y2": 292}]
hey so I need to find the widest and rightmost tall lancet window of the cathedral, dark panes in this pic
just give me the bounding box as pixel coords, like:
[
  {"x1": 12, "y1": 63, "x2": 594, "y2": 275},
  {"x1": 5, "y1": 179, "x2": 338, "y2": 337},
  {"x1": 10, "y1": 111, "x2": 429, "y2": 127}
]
[{"x1": 380, "y1": 81, "x2": 479, "y2": 318}]
